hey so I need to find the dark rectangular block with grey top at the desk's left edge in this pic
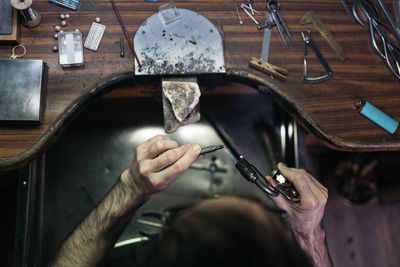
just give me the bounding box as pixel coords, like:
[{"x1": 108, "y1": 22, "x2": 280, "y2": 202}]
[{"x1": 0, "y1": 59, "x2": 47, "y2": 123}]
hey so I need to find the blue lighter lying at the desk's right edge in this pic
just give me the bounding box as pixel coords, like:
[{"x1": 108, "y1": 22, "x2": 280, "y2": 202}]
[{"x1": 356, "y1": 100, "x2": 399, "y2": 134}]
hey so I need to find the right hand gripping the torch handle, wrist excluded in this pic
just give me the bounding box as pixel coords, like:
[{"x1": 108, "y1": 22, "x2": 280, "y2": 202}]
[{"x1": 268, "y1": 163, "x2": 328, "y2": 238}]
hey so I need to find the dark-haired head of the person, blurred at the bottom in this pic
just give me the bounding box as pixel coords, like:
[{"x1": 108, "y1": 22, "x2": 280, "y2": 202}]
[{"x1": 148, "y1": 197, "x2": 311, "y2": 267}]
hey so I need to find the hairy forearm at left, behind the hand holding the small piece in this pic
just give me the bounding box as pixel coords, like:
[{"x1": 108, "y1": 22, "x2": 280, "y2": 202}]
[{"x1": 52, "y1": 171, "x2": 148, "y2": 267}]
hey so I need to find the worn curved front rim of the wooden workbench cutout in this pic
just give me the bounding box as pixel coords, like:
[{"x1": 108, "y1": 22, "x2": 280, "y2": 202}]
[{"x1": 0, "y1": 69, "x2": 399, "y2": 170}]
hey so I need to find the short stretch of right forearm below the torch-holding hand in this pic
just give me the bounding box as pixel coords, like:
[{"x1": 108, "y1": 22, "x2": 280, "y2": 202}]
[{"x1": 294, "y1": 228, "x2": 333, "y2": 267}]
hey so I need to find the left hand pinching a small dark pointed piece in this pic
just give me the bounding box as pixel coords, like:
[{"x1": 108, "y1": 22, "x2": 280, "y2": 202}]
[{"x1": 121, "y1": 135, "x2": 201, "y2": 194}]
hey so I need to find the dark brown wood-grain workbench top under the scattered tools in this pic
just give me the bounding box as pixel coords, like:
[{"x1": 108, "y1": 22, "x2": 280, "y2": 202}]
[{"x1": 0, "y1": 0, "x2": 400, "y2": 169}]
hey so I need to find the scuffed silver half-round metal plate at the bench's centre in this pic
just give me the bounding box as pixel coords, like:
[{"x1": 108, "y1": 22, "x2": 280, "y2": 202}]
[{"x1": 134, "y1": 9, "x2": 225, "y2": 75}]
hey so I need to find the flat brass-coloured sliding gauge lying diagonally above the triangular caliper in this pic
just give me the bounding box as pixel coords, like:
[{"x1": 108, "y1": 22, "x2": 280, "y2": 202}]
[{"x1": 300, "y1": 9, "x2": 347, "y2": 61}]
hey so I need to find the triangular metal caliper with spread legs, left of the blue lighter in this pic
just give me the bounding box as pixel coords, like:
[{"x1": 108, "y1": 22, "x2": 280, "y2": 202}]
[{"x1": 301, "y1": 31, "x2": 333, "y2": 83}]
